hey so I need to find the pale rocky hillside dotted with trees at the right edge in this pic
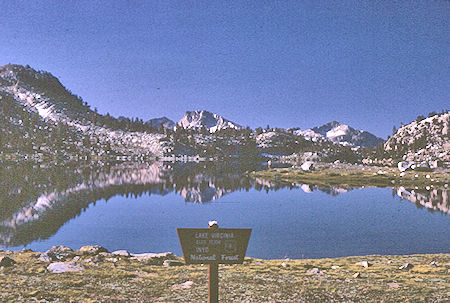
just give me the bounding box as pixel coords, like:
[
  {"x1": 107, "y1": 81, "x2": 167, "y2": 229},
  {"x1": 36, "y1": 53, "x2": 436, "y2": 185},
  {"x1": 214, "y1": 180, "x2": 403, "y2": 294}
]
[{"x1": 384, "y1": 111, "x2": 450, "y2": 161}]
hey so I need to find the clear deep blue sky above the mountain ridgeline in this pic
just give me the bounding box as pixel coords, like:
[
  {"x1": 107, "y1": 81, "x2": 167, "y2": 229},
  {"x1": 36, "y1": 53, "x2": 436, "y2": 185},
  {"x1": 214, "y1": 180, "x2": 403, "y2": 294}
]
[{"x1": 0, "y1": 0, "x2": 450, "y2": 138}]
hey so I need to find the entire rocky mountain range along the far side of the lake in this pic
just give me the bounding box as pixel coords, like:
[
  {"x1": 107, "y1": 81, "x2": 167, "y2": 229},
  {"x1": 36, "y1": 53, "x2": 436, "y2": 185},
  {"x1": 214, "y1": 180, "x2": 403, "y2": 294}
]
[{"x1": 0, "y1": 64, "x2": 450, "y2": 165}]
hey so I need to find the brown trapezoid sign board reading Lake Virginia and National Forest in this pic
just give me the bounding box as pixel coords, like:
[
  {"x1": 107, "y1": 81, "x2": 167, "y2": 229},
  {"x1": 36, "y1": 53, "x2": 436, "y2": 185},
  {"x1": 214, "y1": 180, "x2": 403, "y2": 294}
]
[{"x1": 177, "y1": 228, "x2": 252, "y2": 264}]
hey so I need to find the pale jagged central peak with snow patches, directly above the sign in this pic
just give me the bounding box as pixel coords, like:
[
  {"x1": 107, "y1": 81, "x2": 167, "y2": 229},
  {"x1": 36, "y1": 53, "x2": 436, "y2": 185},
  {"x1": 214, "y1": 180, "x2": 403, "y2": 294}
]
[{"x1": 177, "y1": 110, "x2": 242, "y2": 132}]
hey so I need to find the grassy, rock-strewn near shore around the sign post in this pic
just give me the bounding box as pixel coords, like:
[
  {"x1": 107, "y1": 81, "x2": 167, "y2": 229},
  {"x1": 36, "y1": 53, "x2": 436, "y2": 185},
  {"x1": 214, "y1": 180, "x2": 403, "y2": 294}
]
[{"x1": 0, "y1": 245, "x2": 450, "y2": 302}]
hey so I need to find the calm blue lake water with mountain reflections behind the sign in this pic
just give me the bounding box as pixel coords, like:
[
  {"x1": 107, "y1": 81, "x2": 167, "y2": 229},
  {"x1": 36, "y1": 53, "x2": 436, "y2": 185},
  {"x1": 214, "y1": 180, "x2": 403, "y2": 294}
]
[{"x1": 0, "y1": 163, "x2": 450, "y2": 258}]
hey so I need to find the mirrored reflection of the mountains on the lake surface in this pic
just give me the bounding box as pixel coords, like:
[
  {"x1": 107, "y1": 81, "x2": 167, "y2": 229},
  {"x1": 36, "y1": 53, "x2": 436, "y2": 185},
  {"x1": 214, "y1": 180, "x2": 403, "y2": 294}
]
[{"x1": 0, "y1": 162, "x2": 449, "y2": 246}]
